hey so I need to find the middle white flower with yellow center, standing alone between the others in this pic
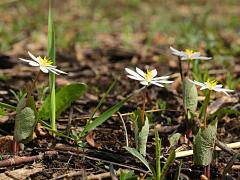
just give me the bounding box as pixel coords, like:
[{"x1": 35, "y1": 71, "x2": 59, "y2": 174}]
[{"x1": 125, "y1": 67, "x2": 173, "y2": 87}]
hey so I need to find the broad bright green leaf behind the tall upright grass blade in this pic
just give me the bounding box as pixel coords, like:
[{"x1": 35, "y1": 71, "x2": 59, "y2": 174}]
[{"x1": 39, "y1": 83, "x2": 87, "y2": 120}]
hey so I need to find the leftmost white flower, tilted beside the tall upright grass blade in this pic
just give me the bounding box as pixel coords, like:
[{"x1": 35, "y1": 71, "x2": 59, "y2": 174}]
[{"x1": 19, "y1": 51, "x2": 67, "y2": 75}]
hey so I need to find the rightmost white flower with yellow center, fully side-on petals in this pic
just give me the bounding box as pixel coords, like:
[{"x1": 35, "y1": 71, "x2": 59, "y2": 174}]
[{"x1": 190, "y1": 79, "x2": 233, "y2": 96}]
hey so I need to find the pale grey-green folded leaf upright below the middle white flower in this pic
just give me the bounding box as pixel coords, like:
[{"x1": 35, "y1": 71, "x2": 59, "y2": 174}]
[{"x1": 137, "y1": 115, "x2": 149, "y2": 156}]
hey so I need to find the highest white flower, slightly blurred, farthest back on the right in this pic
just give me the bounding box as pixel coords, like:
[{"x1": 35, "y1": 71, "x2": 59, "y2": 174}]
[{"x1": 170, "y1": 46, "x2": 212, "y2": 60}]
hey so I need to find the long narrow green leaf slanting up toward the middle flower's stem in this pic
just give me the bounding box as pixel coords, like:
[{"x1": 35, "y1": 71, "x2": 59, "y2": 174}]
[{"x1": 80, "y1": 96, "x2": 130, "y2": 137}]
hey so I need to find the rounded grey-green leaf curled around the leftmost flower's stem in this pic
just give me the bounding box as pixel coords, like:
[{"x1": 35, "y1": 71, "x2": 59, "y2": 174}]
[{"x1": 14, "y1": 96, "x2": 36, "y2": 143}]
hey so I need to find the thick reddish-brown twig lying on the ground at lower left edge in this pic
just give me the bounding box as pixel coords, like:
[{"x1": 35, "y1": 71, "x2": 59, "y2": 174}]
[{"x1": 0, "y1": 151, "x2": 57, "y2": 167}]
